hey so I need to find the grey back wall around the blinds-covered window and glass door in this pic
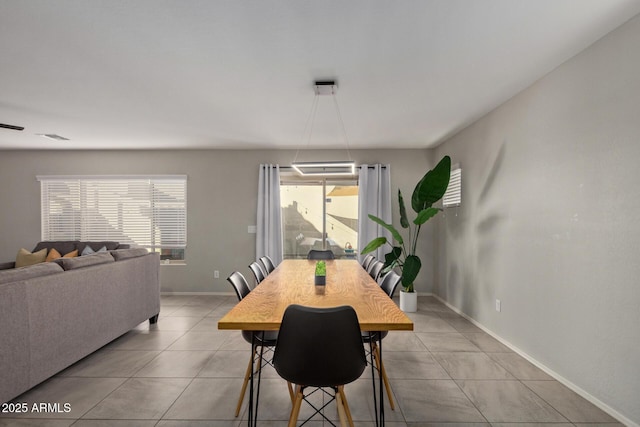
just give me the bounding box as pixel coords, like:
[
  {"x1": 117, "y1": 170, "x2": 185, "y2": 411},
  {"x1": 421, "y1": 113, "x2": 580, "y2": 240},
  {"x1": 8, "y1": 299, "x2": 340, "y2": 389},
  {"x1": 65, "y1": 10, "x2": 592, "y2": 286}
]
[{"x1": 0, "y1": 150, "x2": 435, "y2": 292}]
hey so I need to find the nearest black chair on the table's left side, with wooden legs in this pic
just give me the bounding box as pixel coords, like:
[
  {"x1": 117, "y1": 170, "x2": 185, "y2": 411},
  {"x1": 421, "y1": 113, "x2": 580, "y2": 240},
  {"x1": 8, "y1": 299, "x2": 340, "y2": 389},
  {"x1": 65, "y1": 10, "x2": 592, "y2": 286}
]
[{"x1": 227, "y1": 271, "x2": 282, "y2": 417}]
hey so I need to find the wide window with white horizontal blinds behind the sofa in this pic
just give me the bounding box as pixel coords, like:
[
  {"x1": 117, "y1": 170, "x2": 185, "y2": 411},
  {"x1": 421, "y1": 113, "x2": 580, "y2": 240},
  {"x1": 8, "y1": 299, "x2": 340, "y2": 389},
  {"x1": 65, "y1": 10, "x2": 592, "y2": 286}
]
[{"x1": 38, "y1": 175, "x2": 187, "y2": 262}]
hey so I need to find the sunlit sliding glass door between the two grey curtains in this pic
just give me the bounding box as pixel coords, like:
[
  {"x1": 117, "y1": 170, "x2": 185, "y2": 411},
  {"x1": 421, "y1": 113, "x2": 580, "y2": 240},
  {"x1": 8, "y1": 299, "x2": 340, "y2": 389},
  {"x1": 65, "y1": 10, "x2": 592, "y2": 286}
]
[{"x1": 280, "y1": 177, "x2": 358, "y2": 259}]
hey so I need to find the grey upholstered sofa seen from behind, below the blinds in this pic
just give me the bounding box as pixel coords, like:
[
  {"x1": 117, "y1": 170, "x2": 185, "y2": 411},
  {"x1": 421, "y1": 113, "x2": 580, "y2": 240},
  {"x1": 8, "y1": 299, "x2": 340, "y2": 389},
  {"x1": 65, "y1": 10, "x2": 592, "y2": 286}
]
[{"x1": 0, "y1": 242, "x2": 160, "y2": 402}]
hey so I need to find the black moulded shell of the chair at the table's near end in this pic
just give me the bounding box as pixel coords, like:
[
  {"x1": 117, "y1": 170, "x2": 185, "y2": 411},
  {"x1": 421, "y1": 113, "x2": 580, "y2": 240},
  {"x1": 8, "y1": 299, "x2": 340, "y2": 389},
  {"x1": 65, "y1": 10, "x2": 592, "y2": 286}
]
[{"x1": 273, "y1": 304, "x2": 367, "y2": 387}]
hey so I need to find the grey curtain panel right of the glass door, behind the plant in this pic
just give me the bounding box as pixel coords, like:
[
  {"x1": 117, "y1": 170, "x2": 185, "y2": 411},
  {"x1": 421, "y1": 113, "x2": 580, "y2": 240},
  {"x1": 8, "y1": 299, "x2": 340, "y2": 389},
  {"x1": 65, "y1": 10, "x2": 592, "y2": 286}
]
[{"x1": 358, "y1": 164, "x2": 392, "y2": 261}]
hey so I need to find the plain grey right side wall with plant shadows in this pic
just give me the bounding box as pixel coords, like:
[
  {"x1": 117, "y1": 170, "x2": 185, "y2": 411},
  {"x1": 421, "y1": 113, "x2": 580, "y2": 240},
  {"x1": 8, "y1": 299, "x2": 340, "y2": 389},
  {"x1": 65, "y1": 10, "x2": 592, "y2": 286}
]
[{"x1": 434, "y1": 12, "x2": 640, "y2": 424}]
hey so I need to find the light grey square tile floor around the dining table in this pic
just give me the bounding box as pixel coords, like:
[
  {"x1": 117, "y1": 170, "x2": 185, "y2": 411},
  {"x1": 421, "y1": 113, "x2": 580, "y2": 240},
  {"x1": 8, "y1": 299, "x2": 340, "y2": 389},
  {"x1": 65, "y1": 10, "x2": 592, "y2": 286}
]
[{"x1": 0, "y1": 296, "x2": 620, "y2": 427}]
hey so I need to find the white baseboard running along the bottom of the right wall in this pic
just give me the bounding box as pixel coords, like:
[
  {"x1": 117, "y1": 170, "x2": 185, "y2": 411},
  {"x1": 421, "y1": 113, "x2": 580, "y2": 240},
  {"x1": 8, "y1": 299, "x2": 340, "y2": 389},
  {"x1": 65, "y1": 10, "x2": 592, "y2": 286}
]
[{"x1": 430, "y1": 293, "x2": 640, "y2": 427}]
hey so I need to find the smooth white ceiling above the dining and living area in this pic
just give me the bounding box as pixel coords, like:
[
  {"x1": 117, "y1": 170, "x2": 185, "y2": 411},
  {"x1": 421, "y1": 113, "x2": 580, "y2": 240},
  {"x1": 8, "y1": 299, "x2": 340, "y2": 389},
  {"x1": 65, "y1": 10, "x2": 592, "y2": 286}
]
[{"x1": 0, "y1": 0, "x2": 640, "y2": 149}]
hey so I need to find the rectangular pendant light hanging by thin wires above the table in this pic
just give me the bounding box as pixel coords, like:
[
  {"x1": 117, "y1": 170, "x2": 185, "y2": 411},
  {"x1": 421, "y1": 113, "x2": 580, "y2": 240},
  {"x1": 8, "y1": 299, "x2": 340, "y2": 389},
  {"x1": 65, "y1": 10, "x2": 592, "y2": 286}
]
[{"x1": 291, "y1": 80, "x2": 356, "y2": 176}]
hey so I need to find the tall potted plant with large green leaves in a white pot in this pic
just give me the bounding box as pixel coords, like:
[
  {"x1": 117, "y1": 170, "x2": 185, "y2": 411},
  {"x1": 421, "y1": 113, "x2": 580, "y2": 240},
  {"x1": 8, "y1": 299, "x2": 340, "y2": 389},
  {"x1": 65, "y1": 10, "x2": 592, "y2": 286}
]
[{"x1": 362, "y1": 156, "x2": 451, "y2": 311}]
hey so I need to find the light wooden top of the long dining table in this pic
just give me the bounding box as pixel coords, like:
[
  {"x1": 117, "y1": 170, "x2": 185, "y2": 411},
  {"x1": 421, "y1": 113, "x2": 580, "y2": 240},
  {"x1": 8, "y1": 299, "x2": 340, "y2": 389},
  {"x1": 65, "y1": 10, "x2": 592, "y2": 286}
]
[{"x1": 218, "y1": 260, "x2": 413, "y2": 331}]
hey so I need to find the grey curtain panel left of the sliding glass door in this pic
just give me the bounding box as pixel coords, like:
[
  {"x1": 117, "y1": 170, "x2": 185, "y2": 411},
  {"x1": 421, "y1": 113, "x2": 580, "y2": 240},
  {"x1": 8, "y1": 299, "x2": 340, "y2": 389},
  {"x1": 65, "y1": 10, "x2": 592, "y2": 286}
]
[{"x1": 256, "y1": 165, "x2": 283, "y2": 265}]
